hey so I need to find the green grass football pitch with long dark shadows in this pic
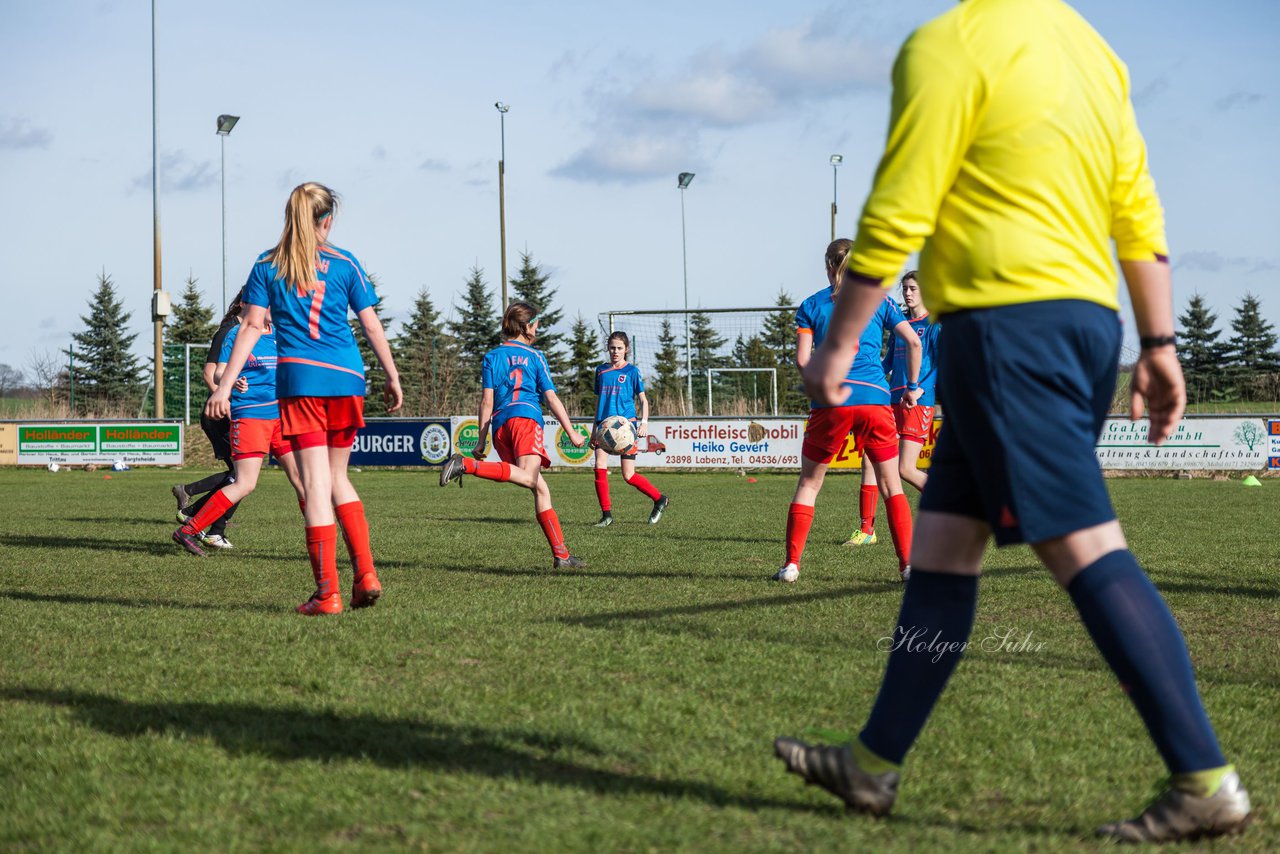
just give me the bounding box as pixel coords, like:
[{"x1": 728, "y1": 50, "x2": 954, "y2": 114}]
[{"x1": 0, "y1": 469, "x2": 1280, "y2": 851}]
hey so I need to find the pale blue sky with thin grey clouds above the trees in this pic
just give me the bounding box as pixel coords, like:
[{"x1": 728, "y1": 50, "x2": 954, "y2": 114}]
[{"x1": 0, "y1": 0, "x2": 1280, "y2": 369}]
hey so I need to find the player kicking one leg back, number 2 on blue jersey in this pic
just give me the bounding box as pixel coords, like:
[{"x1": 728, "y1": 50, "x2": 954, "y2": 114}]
[{"x1": 440, "y1": 302, "x2": 586, "y2": 570}]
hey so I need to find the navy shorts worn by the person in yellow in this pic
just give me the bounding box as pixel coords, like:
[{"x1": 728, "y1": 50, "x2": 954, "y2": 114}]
[{"x1": 920, "y1": 300, "x2": 1121, "y2": 545}]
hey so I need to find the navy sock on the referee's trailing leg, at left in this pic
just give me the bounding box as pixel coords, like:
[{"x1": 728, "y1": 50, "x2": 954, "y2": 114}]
[{"x1": 858, "y1": 567, "x2": 978, "y2": 764}]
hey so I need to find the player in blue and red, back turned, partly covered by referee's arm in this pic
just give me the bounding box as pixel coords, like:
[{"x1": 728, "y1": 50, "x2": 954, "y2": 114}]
[{"x1": 773, "y1": 239, "x2": 920, "y2": 583}]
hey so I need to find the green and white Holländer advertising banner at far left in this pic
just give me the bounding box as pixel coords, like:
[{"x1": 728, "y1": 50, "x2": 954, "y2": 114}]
[{"x1": 15, "y1": 421, "x2": 183, "y2": 466}]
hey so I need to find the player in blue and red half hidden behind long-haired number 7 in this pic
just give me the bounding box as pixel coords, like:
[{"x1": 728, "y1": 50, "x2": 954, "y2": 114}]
[{"x1": 173, "y1": 307, "x2": 306, "y2": 557}]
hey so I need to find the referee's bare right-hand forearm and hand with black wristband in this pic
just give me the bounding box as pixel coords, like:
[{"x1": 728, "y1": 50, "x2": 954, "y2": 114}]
[{"x1": 1120, "y1": 261, "x2": 1187, "y2": 444}]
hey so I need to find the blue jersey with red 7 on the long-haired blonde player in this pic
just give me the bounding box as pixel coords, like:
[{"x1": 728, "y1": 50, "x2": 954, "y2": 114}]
[{"x1": 243, "y1": 243, "x2": 378, "y2": 398}]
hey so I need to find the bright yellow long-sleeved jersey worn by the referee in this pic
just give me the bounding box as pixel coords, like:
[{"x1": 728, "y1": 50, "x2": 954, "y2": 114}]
[{"x1": 847, "y1": 0, "x2": 1169, "y2": 316}]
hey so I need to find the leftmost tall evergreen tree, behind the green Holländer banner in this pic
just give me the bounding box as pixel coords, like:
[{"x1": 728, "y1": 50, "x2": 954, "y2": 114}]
[{"x1": 72, "y1": 271, "x2": 143, "y2": 410}]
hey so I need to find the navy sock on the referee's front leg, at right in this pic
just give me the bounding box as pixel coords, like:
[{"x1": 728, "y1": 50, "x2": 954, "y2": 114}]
[{"x1": 1064, "y1": 549, "x2": 1226, "y2": 773}]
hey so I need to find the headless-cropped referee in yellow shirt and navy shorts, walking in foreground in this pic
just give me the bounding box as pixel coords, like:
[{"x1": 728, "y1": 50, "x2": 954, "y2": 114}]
[{"x1": 774, "y1": 0, "x2": 1251, "y2": 841}]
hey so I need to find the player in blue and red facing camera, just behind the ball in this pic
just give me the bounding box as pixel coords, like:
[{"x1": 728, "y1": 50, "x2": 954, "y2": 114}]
[{"x1": 595, "y1": 332, "x2": 671, "y2": 528}]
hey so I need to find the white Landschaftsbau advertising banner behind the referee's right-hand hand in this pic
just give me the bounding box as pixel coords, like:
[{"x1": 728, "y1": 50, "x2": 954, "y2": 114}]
[{"x1": 1094, "y1": 416, "x2": 1271, "y2": 471}]
